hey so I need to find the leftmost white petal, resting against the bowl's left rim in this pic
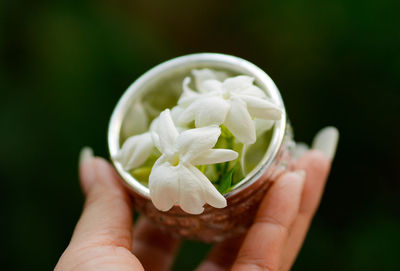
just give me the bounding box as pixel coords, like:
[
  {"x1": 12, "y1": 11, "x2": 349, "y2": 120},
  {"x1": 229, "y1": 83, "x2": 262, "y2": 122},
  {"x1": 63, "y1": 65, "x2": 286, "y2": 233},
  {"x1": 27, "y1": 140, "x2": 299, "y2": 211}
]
[{"x1": 114, "y1": 133, "x2": 154, "y2": 170}]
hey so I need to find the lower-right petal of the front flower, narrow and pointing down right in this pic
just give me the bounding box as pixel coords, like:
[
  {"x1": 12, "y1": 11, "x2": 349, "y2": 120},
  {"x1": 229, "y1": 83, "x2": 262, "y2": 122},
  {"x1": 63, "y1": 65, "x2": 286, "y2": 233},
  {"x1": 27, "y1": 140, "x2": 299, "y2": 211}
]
[{"x1": 188, "y1": 166, "x2": 226, "y2": 208}]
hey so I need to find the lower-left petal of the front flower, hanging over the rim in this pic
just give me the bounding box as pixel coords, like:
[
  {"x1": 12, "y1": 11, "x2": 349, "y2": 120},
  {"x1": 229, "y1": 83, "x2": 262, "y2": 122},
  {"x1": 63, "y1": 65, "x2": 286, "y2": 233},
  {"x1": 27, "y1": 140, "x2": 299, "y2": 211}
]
[{"x1": 149, "y1": 155, "x2": 181, "y2": 211}]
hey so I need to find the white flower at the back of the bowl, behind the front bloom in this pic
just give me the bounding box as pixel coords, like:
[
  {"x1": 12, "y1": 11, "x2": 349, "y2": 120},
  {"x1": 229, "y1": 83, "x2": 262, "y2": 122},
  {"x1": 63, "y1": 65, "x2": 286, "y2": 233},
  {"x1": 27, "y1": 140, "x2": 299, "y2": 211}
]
[{"x1": 177, "y1": 73, "x2": 282, "y2": 144}]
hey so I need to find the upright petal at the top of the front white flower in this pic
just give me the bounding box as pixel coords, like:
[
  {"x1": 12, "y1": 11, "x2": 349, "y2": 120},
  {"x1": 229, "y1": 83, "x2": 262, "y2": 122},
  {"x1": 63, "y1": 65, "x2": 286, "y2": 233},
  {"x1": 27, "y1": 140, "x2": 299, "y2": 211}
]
[{"x1": 156, "y1": 109, "x2": 179, "y2": 154}]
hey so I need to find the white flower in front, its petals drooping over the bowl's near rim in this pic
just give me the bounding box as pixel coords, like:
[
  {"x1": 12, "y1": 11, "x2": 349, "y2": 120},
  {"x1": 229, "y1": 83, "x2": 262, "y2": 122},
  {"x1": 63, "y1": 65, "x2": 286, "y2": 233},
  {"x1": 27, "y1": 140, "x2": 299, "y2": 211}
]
[{"x1": 149, "y1": 109, "x2": 238, "y2": 214}]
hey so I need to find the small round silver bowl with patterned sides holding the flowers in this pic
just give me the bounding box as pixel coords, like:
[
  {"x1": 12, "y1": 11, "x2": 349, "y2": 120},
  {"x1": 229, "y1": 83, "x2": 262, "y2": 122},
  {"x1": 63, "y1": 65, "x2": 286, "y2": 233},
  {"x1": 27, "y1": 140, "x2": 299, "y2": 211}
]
[{"x1": 108, "y1": 53, "x2": 294, "y2": 242}]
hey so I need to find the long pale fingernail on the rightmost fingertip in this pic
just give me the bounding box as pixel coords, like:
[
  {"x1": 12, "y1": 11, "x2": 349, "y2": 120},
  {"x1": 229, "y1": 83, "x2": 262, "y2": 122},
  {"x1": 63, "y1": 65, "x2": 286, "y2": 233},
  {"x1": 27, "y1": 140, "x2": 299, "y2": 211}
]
[{"x1": 312, "y1": 127, "x2": 339, "y2": 160}]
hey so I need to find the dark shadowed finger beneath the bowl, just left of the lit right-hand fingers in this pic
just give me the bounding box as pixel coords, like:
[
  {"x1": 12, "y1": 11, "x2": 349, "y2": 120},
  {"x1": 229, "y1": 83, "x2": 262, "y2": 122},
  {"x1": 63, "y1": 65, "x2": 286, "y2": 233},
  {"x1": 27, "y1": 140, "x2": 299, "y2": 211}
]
[{"x1": 197, "y1": 235, "x2": 245, "y2": 271}]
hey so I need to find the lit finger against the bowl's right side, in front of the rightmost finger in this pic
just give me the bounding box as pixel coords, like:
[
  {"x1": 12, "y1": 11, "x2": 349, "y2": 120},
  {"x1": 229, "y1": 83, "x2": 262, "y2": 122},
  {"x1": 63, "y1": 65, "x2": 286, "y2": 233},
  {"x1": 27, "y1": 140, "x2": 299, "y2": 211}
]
[{"x1": 232, "y1": 171, "x2": 305, "y2": 271}]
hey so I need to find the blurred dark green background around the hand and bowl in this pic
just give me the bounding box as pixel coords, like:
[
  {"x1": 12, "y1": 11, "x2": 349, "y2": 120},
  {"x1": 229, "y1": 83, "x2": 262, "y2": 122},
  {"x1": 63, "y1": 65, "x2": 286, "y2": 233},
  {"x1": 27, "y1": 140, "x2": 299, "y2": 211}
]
[{"x1": 0, "y1": 0, "x2": 400, "y2": 270}]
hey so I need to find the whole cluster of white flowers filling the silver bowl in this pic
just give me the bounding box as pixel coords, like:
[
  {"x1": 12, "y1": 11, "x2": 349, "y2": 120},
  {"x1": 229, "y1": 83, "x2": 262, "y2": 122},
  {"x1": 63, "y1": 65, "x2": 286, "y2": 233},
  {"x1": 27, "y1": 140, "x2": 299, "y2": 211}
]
[{"x1": 114, "y1": 69, "x2": 282, "y2": 214}]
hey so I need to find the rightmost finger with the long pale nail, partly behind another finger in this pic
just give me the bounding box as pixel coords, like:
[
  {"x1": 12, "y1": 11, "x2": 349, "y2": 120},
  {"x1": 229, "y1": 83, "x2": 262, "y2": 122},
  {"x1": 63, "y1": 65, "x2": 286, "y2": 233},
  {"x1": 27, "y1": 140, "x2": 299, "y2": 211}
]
[{"x1": 281, "y1": 127, "x2": 339, "y2": 270}]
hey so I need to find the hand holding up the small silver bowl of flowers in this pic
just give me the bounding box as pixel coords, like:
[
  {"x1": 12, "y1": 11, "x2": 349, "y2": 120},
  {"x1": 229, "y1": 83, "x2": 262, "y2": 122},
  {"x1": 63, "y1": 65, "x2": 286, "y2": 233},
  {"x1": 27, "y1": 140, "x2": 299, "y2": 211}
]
[{"x1": 55, "y1": 128, "x2": 338, "y2": 271}]
